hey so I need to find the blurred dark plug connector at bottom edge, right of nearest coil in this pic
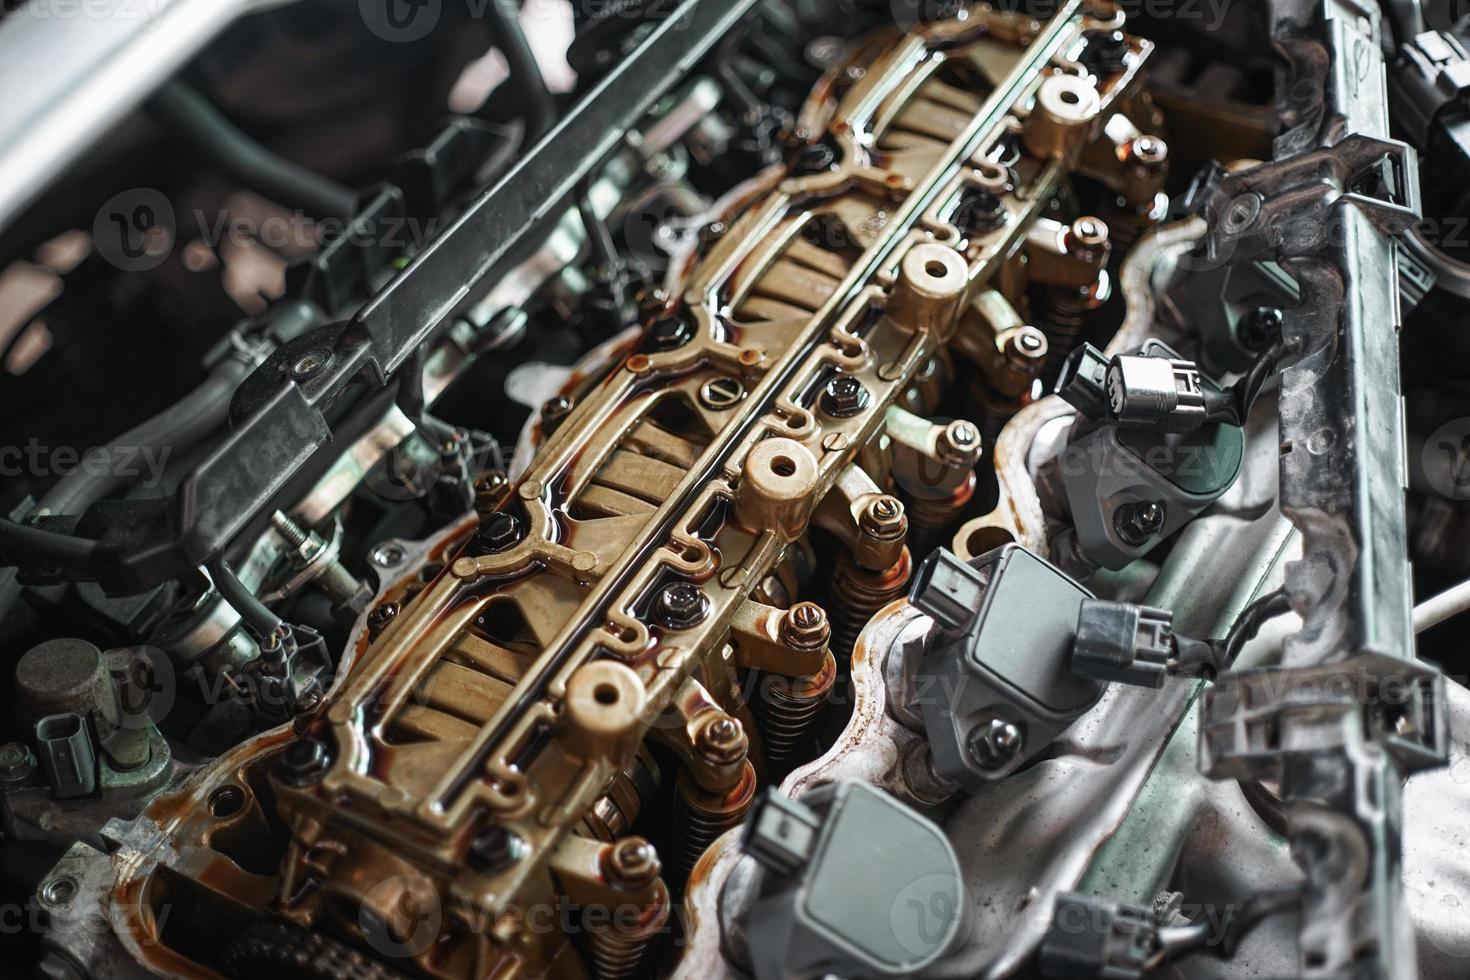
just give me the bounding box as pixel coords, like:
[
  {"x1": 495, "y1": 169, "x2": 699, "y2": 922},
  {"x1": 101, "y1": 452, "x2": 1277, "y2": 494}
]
[{"x1": 1041, "y1": 892, "x2": 1158, "y2": 980}]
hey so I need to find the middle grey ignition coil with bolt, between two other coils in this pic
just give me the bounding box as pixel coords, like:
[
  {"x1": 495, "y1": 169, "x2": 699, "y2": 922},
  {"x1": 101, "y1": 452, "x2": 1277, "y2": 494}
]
[{"x1": 907, "y1": 545, "x2": 1101, "y2": 792}]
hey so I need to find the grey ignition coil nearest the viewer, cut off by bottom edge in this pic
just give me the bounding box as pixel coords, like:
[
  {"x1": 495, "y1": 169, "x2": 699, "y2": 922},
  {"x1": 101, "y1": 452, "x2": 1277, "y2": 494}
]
[{"x1": 744, "y1": 780, "x2": 969, "y2": 980}]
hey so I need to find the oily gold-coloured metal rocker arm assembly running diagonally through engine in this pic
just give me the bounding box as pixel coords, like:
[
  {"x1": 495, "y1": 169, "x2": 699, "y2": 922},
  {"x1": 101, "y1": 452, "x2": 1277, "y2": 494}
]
[{"x1": 111, "y1": 0, "x2": 1148, "y2": 977}]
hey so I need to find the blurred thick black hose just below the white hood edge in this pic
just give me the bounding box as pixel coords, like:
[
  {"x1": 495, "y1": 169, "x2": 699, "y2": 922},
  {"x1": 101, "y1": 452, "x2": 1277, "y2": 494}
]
[{"x1": 148, "y1": 79, "x2": 357, "y2": 219}]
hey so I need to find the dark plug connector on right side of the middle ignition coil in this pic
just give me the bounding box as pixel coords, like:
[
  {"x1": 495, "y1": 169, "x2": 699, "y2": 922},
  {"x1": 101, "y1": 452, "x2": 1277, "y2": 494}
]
[{"x1": 1072, "y1": 599, "x2": 1175, "y2": 688}]
